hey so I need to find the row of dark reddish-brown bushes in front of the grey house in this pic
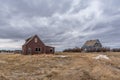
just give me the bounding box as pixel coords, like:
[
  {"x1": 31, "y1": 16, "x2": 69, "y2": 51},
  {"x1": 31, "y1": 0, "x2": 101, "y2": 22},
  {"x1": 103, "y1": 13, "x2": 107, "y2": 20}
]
[{"x1": 63, "y1": 47, "x2": 120, "y2": 52}]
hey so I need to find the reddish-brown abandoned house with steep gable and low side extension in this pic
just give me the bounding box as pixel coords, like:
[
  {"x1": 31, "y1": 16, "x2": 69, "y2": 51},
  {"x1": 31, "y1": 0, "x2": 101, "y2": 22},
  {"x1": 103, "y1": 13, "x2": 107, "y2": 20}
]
[{"x1": 22, "y1": 35, "x2": 55, "y2": 55}]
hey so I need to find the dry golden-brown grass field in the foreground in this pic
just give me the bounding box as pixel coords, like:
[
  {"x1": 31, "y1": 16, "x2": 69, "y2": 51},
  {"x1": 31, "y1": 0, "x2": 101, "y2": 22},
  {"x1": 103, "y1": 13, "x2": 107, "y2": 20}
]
[{"x1": 0, "y1": 53, "x2": 120, "y2": 80}]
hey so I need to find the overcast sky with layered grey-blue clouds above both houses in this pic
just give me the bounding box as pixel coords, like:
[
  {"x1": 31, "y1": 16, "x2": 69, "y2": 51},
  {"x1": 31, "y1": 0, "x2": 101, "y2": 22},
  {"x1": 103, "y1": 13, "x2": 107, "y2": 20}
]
[{"x1": 0, "y1": 0, "x2": 120, "y2": 50}]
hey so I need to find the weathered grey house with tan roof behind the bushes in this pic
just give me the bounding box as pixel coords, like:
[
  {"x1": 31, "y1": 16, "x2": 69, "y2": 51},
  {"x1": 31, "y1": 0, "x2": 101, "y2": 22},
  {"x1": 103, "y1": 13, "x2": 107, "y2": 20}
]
[{"x1": 82, "y1": 39, "x2": 102, "y2": 51}]
